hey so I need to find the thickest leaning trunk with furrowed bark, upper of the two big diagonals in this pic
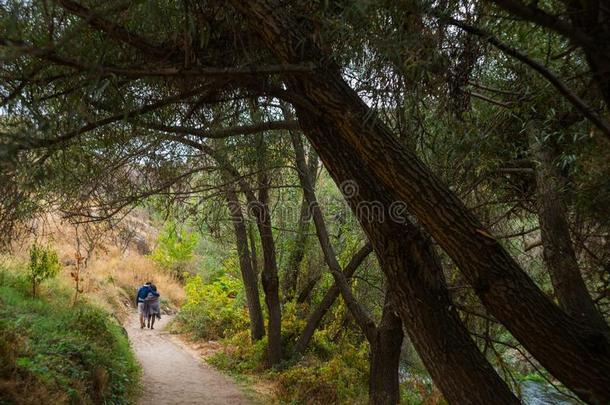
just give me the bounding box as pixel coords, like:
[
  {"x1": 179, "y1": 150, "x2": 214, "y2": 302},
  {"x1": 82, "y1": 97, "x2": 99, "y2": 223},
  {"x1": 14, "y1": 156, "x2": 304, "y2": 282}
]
[{"x1": 231, "y1": 0, "x2": 610, "y2": 402}]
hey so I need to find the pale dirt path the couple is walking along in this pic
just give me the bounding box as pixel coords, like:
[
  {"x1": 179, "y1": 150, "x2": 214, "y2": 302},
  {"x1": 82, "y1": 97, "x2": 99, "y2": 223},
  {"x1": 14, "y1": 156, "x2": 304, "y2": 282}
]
[{"x1": 126, "y1": 314, "x2": 250, "y2": 405}]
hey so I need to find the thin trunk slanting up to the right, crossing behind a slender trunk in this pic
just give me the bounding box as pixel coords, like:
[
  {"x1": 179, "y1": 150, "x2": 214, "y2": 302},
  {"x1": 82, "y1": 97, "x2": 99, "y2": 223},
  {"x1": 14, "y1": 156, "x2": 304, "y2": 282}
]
[{"x1": 294, "y1": 243, "x2": 373, "y2": 354}]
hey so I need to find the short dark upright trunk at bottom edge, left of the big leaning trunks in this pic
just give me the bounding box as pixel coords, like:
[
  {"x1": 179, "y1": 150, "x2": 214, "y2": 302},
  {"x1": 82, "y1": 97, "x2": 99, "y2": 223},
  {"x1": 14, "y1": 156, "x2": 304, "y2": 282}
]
[{"x1": 369, "y1": 288, "x2": 403, "y2": 405}]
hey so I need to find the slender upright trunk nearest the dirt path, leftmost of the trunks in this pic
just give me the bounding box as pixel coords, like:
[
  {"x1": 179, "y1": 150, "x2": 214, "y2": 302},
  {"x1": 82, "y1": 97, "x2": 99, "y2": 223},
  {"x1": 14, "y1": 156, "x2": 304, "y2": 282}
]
[{"x1": 226, "y1": 186, "x2": 265, "y2": 341}]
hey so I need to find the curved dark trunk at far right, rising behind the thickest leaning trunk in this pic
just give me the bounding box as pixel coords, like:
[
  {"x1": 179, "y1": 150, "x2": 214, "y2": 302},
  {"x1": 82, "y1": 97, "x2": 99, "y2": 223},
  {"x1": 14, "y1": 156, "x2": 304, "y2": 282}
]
[{"x1": 531, "y1": 136, "x2": 610, "y2": 333}]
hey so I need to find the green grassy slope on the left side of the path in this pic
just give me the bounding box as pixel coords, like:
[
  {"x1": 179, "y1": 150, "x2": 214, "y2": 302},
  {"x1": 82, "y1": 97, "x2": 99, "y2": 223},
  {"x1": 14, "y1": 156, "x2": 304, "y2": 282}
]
[{"x1": 0, "y1": 270, "x2": 139, "y2": 404}]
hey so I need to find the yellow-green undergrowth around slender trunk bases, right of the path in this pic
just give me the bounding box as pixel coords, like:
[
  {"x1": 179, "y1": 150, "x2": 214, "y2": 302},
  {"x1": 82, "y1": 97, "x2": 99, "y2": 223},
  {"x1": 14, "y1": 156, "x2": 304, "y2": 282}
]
[{"x1": 173, "y1": 269, "x2": 445, "y2": 405}]
